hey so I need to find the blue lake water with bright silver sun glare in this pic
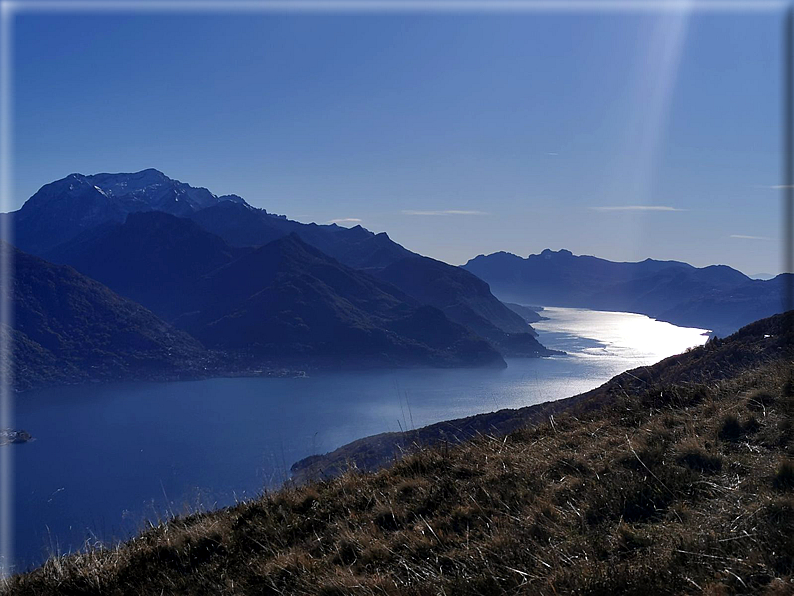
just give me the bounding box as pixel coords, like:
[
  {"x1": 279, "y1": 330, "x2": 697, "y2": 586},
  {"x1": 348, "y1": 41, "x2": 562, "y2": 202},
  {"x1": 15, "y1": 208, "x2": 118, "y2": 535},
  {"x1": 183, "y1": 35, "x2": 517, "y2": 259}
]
[{"x1": 9, "y1": 308, "x2": 706, "y2": 569}]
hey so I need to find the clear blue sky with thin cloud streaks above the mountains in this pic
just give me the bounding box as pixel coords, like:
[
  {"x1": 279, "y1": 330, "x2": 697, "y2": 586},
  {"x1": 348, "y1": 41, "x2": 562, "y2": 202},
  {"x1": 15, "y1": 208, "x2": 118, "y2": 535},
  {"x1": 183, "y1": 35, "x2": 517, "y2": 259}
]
[{"x1": 7, "y1": 5, "x2": 782, "y2": 274}]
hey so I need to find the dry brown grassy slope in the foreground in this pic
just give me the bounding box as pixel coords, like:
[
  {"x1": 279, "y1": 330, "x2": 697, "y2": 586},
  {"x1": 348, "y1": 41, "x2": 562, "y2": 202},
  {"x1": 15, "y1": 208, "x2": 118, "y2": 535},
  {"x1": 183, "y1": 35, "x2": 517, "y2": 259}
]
[{"x1": 7, "y1": 313, "x2": 794, "y2": 596}]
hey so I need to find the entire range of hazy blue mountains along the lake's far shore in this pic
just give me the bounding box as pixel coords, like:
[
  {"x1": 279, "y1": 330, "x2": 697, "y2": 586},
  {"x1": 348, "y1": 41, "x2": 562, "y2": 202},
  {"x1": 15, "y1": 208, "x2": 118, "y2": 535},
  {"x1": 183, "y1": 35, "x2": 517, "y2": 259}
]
[{"x1": 1, "y1": 169, "x2": 786, "y2": 386}]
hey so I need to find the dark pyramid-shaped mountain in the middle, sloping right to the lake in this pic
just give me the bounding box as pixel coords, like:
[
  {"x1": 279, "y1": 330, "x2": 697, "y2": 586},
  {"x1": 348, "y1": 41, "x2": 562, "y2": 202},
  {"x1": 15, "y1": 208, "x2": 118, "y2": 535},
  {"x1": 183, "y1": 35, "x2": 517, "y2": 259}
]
[{"x1": 176, "y1": 234, "x2": 504, "y2": 366}]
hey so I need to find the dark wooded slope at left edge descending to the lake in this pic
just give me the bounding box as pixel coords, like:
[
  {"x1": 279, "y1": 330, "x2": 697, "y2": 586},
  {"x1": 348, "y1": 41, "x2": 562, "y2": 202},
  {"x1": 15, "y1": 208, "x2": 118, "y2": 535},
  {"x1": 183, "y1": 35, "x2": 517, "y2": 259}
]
[{"x1": 2, "y1": 243, "x2": 207, "y2": 389}]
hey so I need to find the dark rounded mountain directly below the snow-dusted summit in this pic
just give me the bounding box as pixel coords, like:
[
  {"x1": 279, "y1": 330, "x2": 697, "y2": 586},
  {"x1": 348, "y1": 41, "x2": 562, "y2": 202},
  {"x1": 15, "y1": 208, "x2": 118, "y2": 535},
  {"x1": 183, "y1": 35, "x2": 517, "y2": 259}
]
[{"x1": 44, "y1": 211, "x2": 248, "y2": 320}]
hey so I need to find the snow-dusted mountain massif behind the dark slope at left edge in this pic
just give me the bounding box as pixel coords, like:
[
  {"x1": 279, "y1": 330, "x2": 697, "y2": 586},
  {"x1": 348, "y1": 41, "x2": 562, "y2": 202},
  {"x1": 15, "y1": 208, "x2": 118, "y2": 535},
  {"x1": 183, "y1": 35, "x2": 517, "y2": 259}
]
[{"x1": 3, "y1": 170, "x2": 554, "y2": 388}]
